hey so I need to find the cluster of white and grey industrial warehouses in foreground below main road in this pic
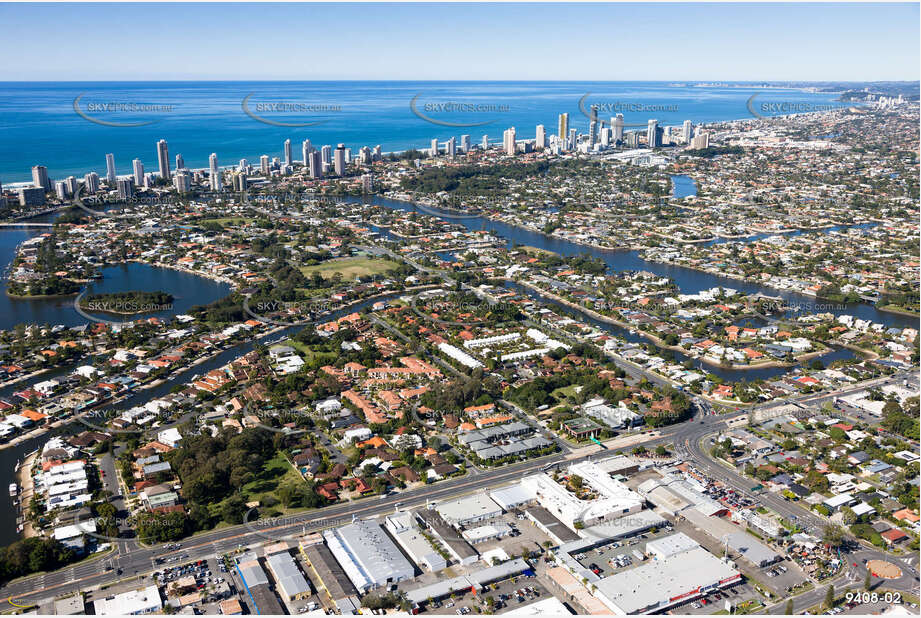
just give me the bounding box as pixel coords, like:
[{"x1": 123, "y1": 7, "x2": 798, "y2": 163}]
[{"x1": 82, "y1": 455, "x2": 820, "y2": 615}]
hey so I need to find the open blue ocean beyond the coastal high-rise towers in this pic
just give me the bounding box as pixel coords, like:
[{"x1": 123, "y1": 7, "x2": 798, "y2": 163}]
[{"x1": 0, "y1": 81, "x2": 852, "y2": 184}]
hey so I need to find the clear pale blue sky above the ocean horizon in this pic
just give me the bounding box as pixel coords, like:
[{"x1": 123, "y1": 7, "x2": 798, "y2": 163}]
[{"x1": 0, "y1": 3, "x2": 921, "y2": 81}]
